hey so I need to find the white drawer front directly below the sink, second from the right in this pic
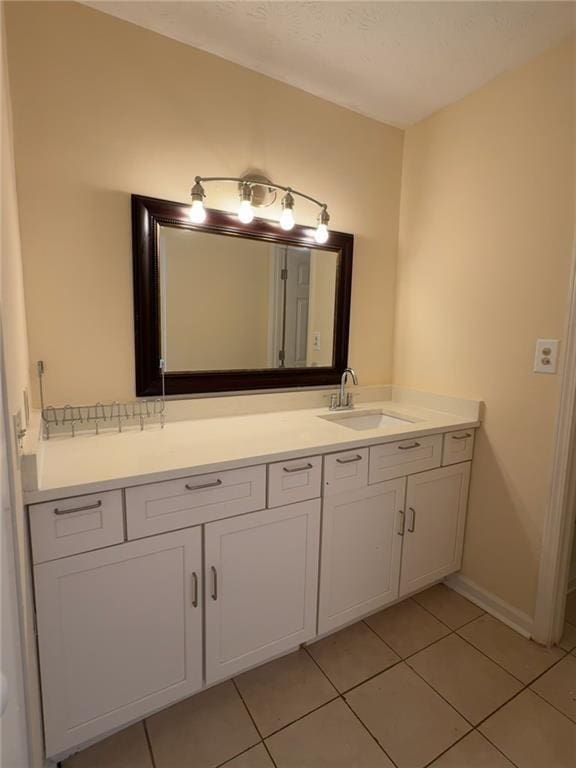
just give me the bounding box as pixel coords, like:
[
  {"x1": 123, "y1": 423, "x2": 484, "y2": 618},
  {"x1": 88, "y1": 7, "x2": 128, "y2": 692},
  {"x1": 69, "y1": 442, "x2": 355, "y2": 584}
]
[{"x1": 368, "y1": 435, "x2": 442, "y2": 483}]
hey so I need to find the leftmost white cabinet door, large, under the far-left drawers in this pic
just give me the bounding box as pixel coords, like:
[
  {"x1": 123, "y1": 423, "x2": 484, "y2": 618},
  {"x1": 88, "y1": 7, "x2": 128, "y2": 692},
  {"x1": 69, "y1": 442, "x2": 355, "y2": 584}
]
[{"x1": 34, "y1": 528, "x2": 202, "y2": 757}]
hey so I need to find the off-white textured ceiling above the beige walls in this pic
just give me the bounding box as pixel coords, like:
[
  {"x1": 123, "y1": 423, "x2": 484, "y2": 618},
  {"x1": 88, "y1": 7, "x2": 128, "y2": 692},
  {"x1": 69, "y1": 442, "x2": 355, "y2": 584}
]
[{"x1": 85, "y1": 0, "x2": 576, "y2": 125}]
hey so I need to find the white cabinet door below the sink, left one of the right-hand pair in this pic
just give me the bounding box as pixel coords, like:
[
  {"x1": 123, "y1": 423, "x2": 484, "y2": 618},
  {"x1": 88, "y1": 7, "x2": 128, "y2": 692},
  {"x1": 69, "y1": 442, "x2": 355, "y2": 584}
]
[{"x1": 318, "y1": 478, "x2": 406, "y2": 634}]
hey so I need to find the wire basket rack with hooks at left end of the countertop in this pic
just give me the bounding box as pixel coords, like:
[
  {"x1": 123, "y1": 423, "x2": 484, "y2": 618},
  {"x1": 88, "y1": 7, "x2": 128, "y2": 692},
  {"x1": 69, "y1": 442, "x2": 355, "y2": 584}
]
[{"x1": 37, "y1": 360, "x2": 166, "y2": 440}]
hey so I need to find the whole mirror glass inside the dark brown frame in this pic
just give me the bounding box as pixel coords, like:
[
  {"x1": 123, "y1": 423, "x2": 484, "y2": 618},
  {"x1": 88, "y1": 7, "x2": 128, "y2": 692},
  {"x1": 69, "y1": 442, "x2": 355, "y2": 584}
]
[{"x1": 158, "y1": 225, "x2": 340, "y2": 372}]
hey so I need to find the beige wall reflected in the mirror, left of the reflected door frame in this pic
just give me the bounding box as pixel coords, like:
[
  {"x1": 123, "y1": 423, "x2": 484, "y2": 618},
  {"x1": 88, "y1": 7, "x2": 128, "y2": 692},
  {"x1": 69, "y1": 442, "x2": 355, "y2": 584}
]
[{"x1": 160, "y1": 227, "x2": 271, "y2": 371}]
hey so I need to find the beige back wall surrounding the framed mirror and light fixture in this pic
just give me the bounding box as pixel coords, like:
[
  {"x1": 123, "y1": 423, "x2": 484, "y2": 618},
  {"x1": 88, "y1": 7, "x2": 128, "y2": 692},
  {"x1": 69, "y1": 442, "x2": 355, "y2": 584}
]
[{"x1": 6, "y1": 2, "x2": 403, "y2": 404}]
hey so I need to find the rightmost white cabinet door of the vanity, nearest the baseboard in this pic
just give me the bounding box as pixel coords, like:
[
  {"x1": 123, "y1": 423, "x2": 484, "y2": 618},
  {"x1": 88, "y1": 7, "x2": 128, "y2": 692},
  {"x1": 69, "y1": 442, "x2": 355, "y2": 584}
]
[{"x1": 400, "y1": 462, "x2": 470, "y2": 597}]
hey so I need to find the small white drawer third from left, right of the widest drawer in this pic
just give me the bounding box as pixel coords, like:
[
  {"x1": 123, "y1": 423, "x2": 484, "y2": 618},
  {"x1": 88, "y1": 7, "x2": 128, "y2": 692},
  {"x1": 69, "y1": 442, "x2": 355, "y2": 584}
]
[{"x1": 268, "y1": 456, "x2": 322, "y2": 507}]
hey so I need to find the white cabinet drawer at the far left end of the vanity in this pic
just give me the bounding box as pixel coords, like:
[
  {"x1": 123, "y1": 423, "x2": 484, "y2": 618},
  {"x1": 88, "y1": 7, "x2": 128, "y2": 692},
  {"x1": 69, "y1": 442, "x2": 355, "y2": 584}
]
[{"x1": 29, "y1": 491, "x2": 124, "y2": 563}]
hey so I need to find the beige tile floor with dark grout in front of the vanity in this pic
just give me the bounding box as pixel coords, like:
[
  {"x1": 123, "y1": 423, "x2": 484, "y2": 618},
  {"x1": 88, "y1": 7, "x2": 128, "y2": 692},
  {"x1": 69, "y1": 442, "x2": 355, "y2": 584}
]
[{"x1": 63, "y1": 585, "x2": 576, "y2": 768}]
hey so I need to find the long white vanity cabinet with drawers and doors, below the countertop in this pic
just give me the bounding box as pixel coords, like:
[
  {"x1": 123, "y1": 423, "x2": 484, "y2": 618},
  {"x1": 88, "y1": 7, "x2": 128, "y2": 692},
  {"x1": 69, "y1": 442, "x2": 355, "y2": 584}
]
[{"x1": 28, "y1": 429, "x2": 474, "y2": 759}]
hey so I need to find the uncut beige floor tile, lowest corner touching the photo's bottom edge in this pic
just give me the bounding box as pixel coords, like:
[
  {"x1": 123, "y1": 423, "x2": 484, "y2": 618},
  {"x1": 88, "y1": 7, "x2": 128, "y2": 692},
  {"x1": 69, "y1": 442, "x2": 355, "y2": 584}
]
[{"x1": 345, "y1": 664, "x2": 470, "y2": 768}]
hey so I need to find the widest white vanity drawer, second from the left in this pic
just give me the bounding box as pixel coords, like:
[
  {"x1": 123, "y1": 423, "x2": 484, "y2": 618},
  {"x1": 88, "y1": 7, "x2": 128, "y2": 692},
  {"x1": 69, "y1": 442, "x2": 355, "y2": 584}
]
[{"x1": 126, "y1": 465, "x2": 266, "y2": 539}]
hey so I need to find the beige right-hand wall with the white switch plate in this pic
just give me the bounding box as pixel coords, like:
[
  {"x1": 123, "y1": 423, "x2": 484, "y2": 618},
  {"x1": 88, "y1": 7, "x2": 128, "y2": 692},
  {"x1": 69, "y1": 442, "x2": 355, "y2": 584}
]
[{"x1": 394, "y1": 43, "x2": 575, "y2": 615}]
